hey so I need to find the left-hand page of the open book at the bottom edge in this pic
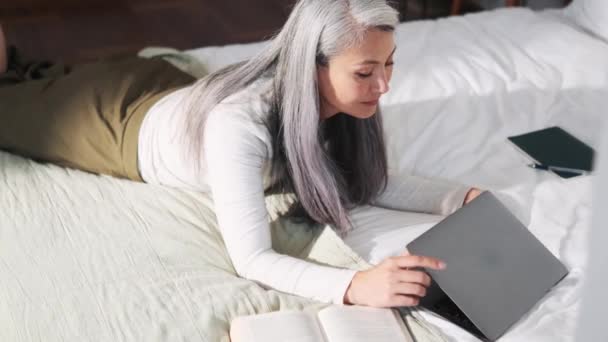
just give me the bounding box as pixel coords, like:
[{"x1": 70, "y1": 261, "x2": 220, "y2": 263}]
[{"x1": 230, "y1": 311, "x2": 325, "y2": 342}]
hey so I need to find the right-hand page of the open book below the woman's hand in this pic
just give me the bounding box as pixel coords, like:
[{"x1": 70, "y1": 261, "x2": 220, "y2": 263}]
[{"x1": 318, "y1": 305, "x2": 412, "y2": 342}]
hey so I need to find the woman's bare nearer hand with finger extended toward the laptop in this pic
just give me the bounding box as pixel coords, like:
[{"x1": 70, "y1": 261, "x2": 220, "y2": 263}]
[{"x1": 344, "y1": 252, "x2": 445, "y2": 307}]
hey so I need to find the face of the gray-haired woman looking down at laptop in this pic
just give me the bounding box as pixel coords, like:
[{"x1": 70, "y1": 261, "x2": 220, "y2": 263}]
[{"x1": 317, "y1": 29, "x2": 395, "y2": 120}]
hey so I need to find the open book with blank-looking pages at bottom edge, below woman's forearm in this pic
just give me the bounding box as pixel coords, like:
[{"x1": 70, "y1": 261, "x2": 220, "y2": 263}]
[{"x1": 230, "y1": 305, "x2": 413, "y2": 342}]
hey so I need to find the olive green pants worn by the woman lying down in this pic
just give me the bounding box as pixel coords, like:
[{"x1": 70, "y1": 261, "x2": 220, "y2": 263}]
[{"x1": 0, "y1": 57, "x2": 195, "y2": 181}]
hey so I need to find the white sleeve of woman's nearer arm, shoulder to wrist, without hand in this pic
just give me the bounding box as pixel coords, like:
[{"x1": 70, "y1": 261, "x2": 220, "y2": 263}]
[{"x1": 203, "y1": 112, "x2": 356, "y2": 304}]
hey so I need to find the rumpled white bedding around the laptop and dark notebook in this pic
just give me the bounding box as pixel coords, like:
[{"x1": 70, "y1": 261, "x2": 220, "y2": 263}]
[{"x1": 192, "y1": 8, "x2": 608, "y2": 341}]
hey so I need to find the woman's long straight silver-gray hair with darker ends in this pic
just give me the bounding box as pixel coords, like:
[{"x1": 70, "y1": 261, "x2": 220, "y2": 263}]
[{"x1": 185, "y1": 0, "x2": 399, "y2": 234}]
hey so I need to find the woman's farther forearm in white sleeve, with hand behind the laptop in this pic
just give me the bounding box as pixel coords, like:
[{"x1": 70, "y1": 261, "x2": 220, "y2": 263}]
[{"x1": 372, "y1": 173, "x2": 478, "y2": 215}]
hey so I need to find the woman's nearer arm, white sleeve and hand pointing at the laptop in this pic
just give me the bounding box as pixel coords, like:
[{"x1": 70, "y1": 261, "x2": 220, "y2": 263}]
[{"x1": 203, "y1": 113, "x2": 466, "y2": 307}]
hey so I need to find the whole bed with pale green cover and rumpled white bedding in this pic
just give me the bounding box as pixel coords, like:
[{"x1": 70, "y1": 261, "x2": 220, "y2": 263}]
[{"x1": 0, "y1": 1, "x2": 608, "y2": 342}]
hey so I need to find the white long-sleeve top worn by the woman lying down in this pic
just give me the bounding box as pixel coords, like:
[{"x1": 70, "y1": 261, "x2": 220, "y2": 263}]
[{"x1": 138, "y1": 78, "x2": 469, "y2": 304}]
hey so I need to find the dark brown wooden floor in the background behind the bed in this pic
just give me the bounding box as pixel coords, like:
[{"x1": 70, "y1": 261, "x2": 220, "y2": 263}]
[{"x1": 0, "y1": 0, "x2": 568, "y2": 63}]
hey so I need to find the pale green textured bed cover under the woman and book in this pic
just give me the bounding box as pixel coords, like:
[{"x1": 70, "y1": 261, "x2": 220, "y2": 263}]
[{"x1": 0, "y1": 156, "x2": 445, "y2": 342}]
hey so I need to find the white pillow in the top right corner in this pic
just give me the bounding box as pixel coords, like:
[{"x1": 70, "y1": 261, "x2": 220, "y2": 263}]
[{"x1": 566, "y1": 0, "x2": 608, "y2": 41}]
